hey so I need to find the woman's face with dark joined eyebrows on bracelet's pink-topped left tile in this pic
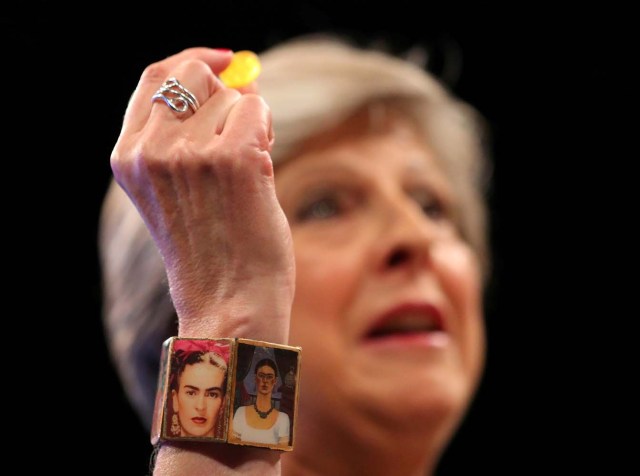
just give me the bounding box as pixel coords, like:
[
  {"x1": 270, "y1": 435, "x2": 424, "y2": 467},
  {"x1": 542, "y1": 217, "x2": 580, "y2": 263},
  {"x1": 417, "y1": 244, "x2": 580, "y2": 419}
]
[{"x1": 173, "y1": 361, "x2": 224, "y2": 436}]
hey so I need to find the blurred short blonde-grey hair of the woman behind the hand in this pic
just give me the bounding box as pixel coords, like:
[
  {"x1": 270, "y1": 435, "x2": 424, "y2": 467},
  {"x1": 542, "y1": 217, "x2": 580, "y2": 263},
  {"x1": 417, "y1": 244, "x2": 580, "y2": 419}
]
[{"x1": 99, "y1": 35, "x2": 489, "y2": 426}]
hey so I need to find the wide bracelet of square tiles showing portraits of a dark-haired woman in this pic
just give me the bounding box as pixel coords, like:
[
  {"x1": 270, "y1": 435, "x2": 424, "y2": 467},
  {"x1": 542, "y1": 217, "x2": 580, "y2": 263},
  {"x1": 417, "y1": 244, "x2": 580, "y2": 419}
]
[{"x1": 151, "y1": 337, "x2": 302, "y2": 451}]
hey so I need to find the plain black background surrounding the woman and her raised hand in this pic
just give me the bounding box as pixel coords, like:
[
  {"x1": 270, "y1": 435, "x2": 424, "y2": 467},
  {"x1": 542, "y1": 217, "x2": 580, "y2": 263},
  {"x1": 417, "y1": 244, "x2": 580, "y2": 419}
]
[{"x1": 0, "y1": 1, "x2": 631, "y2": 476}]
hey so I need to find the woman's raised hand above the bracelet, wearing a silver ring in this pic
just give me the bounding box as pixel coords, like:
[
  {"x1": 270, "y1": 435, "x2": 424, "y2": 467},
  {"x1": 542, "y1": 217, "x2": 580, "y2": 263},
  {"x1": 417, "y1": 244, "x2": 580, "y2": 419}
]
[{"x1": 111, "y1": 48, "x2": 295, "y2": 343}]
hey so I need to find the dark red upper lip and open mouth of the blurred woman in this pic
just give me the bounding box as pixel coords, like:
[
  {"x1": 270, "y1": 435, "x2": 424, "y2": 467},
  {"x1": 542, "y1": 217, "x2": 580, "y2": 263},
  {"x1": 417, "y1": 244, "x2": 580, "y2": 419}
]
[{"x1": 365, "y1": 302, "x2": 446, "y2": 340}]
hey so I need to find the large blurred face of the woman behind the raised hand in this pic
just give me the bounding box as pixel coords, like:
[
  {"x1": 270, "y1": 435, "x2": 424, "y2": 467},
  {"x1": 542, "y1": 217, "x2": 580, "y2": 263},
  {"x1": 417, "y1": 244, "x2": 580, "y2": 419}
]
[{"x1": 275, "y1": 107, "x2": 484, "y2": 436}]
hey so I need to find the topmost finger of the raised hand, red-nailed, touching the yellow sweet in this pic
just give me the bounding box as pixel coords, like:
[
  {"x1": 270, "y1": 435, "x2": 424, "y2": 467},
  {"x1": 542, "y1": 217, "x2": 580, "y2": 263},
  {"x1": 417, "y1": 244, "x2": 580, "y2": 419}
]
[{"x1": 122, "y1": 47, "x2": 233, "y2": 131}]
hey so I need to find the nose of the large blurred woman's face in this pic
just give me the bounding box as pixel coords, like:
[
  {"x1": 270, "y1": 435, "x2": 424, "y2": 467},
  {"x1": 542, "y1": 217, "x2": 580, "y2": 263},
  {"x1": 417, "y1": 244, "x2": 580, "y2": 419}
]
[{"x1": 377, "y1": 197, "x2": 437, "y2": 272}]
